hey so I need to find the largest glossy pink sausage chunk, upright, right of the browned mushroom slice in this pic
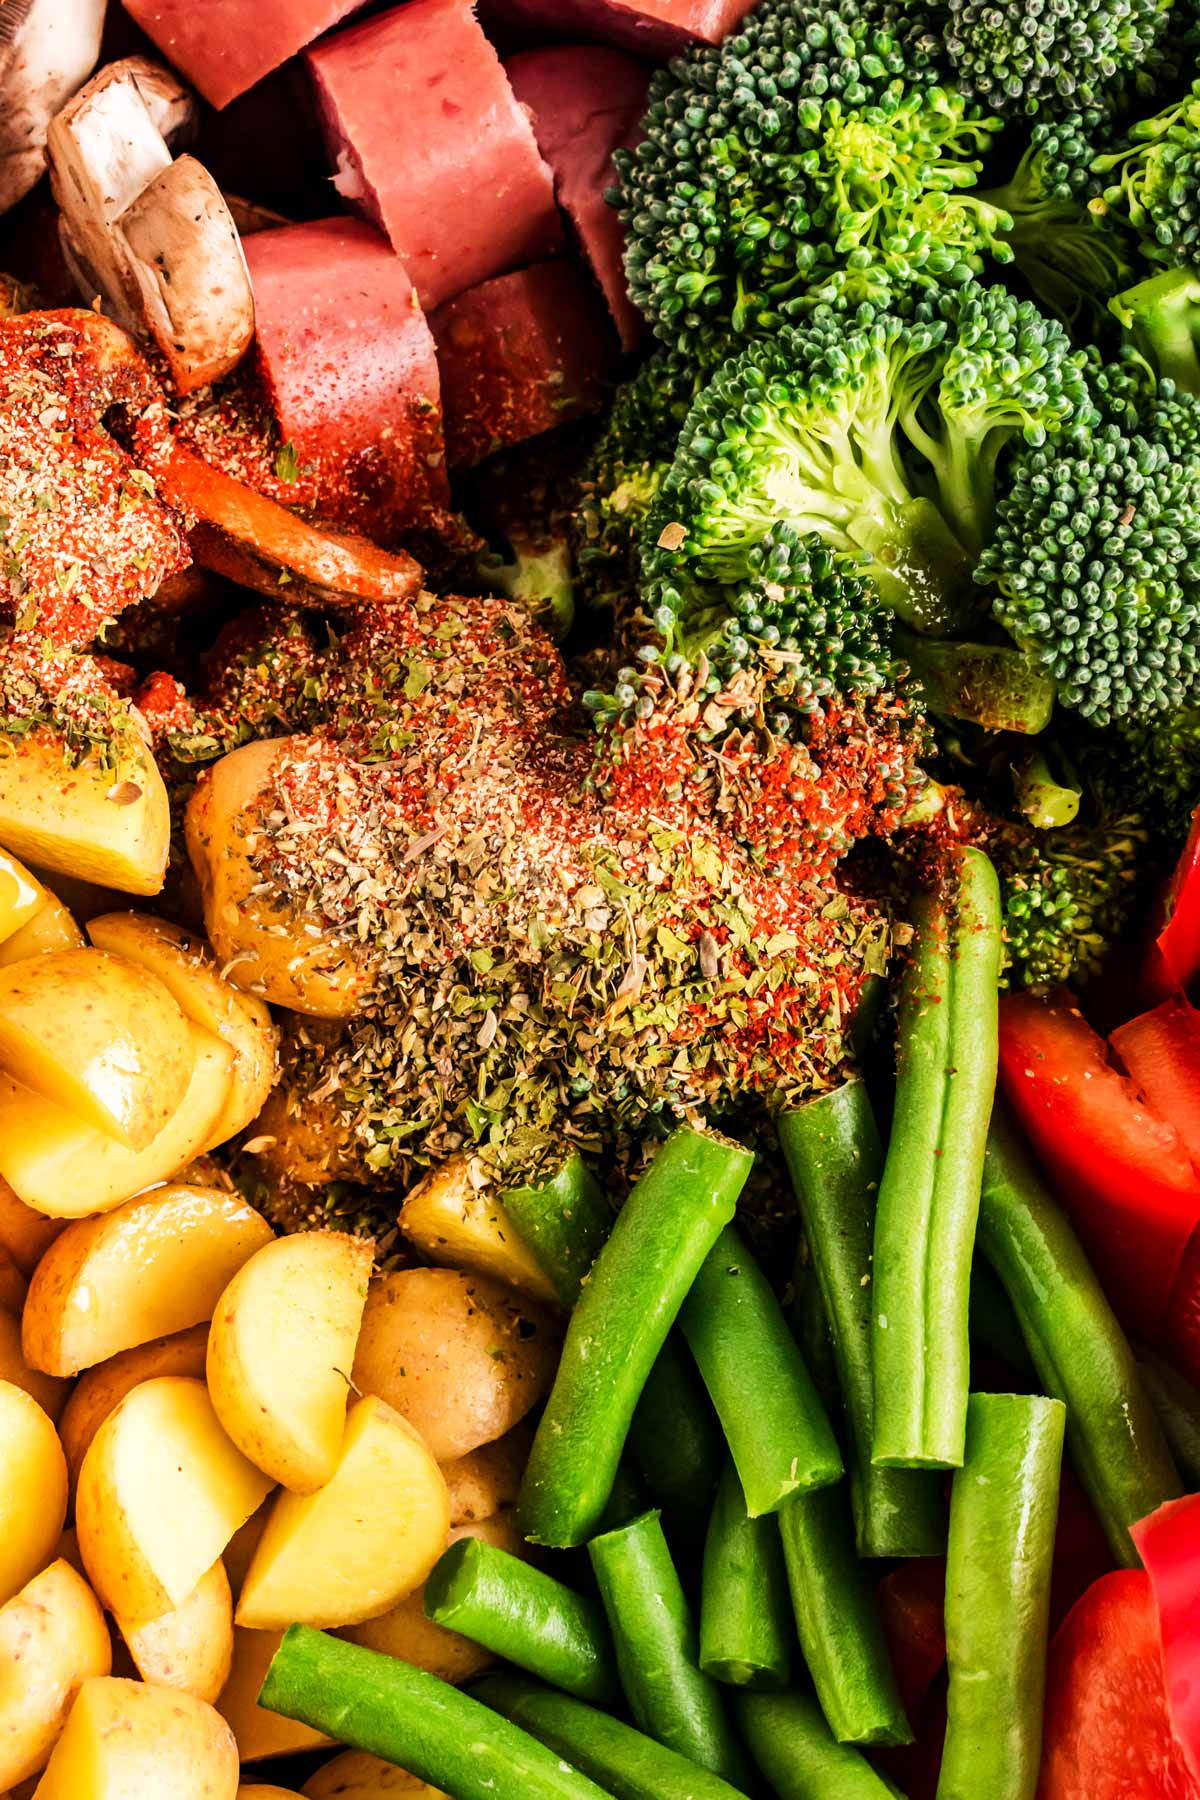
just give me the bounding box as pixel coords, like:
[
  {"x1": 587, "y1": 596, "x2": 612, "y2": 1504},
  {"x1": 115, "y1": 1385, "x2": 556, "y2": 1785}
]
[{"x1": 308, "y1": 0, "x2": 563, "y2": 311}]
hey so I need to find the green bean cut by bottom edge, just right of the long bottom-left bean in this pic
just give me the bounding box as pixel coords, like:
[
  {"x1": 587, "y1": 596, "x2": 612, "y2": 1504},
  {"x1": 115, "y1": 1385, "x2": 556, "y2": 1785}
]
[{"x1": 475, "y1": 1672, "x2": 745, "y2": 1800}]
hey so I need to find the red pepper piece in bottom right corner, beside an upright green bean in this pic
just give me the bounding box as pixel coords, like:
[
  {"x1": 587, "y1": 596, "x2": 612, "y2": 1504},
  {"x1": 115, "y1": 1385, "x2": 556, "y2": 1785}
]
[{"x1": 1038, "y1": 1570, "x2": 1200, "y2": 1800}]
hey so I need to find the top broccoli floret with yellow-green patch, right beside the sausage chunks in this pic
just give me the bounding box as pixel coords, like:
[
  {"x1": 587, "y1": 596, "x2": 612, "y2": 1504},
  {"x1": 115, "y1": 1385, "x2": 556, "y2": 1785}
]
[{"x1": 617, "y1": 0, "x2": 1007, "y2": 353}]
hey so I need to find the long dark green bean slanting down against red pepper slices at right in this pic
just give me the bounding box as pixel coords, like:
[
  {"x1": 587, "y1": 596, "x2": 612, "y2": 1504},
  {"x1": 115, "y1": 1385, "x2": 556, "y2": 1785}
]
[{"x1": 979, "y1": 1103, "x2": 1182, "y2": 1568}]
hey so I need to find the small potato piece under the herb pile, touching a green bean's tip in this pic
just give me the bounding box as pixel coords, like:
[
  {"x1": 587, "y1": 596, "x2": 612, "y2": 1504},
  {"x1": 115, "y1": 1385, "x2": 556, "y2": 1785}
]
[{"x1": 399, "y1": 1156, "x2": 558, "y2": 1307}]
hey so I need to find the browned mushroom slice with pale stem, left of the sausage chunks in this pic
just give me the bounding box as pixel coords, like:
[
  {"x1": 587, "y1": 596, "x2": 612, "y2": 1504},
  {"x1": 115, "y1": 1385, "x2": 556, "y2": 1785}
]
[{"x1": 47, "y1": 56, "x2": 254, "y2": 394}]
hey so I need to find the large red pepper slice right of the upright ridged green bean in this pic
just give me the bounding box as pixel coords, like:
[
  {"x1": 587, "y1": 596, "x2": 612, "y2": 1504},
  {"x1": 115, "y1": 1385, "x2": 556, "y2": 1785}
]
[{"x1": 1000, "y1": 994, "x2": 1200, "y2": 1341}]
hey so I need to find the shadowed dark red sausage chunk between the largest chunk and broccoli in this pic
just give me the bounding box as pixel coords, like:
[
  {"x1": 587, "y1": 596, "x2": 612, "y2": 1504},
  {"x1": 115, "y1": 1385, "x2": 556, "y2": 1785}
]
[{"x1": 504, "y1": 43, "x2": 649, "y2": 349}]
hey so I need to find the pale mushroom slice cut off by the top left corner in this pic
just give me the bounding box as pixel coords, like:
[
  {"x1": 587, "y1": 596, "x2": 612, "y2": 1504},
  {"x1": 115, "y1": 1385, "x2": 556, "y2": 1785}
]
[{"x1": 0, "y1": 0, "x2": 104, "y2": 212}]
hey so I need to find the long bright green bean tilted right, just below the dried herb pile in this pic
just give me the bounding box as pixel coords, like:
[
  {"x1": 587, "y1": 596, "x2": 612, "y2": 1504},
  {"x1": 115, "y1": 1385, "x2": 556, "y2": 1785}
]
[{"x1": 516, "y1": 1129, "x2": 754, "y2": 1548}]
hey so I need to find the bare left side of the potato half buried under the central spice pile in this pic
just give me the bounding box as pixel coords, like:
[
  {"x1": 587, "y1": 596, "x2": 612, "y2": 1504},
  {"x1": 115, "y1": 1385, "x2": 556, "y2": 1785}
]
[{"x1": 186, "y1": 738, "x2": 372, "y2": 1019}]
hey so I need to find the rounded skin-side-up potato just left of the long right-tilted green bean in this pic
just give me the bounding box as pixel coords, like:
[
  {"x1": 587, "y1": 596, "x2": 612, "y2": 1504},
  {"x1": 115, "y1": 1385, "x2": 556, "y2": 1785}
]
[{"x1": 354, "y1": 1269, "x2": 558, "y2": 1462}]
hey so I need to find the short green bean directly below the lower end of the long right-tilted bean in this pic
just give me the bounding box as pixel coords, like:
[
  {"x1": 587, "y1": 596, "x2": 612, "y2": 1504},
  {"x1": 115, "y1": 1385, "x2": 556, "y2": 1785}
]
[{"x1": 588, "y1": 1512, "x2": 745, "y2": 1784}]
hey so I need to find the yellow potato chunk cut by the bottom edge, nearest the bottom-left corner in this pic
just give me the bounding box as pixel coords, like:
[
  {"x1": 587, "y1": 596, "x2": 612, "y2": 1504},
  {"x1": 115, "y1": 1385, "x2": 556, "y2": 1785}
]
[{"x1": 38, "y1": 1676, "x2": 237, "y2": 1800}]
